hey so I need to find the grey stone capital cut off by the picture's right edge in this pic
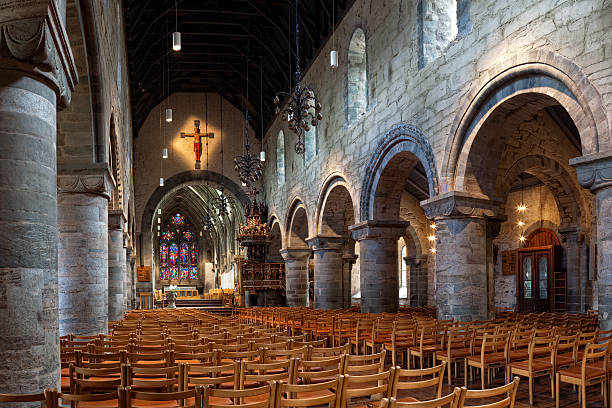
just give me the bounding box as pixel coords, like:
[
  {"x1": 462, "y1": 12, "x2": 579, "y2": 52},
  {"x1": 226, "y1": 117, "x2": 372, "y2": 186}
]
[{"x1": 570, "y1": 150, "x2": 612, "y2": 193}]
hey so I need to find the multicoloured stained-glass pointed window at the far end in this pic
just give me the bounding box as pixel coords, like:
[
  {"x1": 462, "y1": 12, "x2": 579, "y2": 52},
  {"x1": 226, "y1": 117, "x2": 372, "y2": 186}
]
[{"x1": 159, "y1": 213, "x2": 198, "y2": 281}]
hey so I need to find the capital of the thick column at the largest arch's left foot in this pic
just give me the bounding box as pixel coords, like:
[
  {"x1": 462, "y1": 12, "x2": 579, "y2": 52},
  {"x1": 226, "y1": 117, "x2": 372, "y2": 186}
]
[{"x1": 421, "y1": 191, "x2": 504, "y2": 219}]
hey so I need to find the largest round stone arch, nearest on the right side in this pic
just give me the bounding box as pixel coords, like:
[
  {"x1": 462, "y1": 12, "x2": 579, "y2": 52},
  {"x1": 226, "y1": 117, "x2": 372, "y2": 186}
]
[{"x1": 441, "y1": 50, "x2": 610, "y2": 193}]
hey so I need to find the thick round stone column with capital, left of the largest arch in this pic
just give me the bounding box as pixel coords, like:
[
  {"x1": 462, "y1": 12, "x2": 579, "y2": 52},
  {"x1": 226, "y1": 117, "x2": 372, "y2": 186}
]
[{"x1": 421, "y1": 191, "x2": 499, "y2": 321}]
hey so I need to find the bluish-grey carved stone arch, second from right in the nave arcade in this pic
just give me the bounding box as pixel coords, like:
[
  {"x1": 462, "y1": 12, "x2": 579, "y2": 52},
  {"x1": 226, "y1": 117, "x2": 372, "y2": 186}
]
[{"x1": 359, "y1": 123, "x2": 439, "y2": 221}]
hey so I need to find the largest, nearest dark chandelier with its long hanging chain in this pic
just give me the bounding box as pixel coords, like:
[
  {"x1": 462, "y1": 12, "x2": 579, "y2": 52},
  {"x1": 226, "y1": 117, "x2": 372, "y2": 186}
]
[{"x1": 274, "y1": 0, "x2": 323, "y2": 154}]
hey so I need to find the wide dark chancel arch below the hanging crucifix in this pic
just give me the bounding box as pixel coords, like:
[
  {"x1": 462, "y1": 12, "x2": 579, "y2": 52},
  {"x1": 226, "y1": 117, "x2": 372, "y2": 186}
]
[{"x1": 140, "y1": 170, "x2": 249, "y2": 232}]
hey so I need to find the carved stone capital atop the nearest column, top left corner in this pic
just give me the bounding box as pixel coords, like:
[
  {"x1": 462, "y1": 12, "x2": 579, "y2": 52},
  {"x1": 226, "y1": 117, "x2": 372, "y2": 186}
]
[{"x1": 0, "y1": 0, "x2": 79, "y2": 109}]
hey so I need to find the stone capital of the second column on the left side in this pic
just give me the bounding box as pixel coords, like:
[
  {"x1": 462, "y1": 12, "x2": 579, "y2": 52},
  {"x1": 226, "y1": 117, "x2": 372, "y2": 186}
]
[{"x1": 57, "y1": 164, "x2": 115, "y2": 200}]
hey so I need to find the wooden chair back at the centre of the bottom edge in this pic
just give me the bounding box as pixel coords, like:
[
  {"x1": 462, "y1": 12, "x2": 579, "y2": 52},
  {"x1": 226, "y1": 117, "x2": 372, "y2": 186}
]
[{"x1": 273, "y1": 376, "x2": 345, "y2": 408}]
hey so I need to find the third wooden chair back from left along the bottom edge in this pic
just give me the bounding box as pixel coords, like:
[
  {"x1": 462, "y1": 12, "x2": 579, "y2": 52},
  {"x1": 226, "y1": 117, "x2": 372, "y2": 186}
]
[{"x1": 120, "y1": 386, "x2": 203, "y2": 408}]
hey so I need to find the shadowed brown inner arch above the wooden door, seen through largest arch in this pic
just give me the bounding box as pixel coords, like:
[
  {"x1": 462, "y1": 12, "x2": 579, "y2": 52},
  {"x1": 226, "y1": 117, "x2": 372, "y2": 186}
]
[{"x1": 498, "y1": 155, "x2": 589, "y2": 231}]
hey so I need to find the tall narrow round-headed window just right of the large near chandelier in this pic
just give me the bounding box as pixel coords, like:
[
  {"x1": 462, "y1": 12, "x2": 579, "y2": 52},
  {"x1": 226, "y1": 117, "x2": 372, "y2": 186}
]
[{"x1": 347, "y1": 28, "x2": 368, "y2": 123}]
